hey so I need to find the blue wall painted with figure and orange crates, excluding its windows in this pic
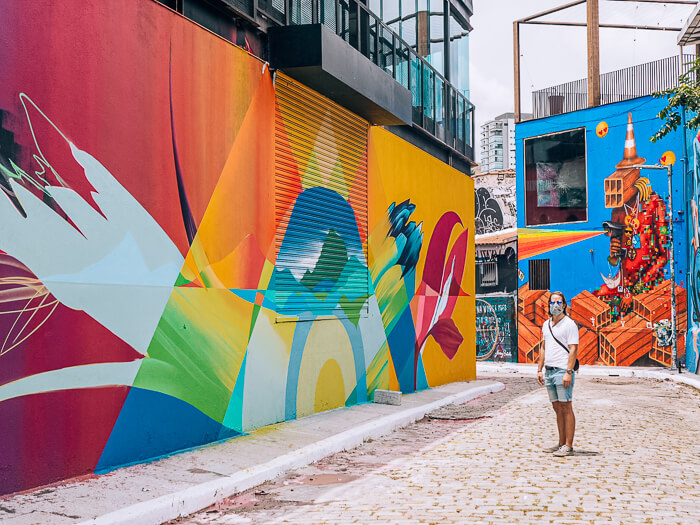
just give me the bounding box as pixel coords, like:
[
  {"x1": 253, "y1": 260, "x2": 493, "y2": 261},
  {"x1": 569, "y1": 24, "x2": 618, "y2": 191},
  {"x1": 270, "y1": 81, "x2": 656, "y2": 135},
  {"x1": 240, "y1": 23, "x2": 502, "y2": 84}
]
[{"x1": 516, "y1": 97, "x2": 688, "y2": 366}]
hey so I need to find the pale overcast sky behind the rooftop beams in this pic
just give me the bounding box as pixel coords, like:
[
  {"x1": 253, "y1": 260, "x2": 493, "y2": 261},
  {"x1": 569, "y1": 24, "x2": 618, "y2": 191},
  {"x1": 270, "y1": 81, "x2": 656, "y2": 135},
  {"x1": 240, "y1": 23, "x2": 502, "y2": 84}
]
[{"x1": 469, "y1": 0, "x2": 694, "y2": 160}]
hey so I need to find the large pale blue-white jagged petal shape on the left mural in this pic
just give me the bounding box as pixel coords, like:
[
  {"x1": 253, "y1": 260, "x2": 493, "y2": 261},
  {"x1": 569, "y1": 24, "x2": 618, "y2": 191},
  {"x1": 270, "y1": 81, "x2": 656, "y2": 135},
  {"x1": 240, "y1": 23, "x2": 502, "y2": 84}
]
[{"x1": 0, "y1": 136, "x2": 184, "y2": 354}]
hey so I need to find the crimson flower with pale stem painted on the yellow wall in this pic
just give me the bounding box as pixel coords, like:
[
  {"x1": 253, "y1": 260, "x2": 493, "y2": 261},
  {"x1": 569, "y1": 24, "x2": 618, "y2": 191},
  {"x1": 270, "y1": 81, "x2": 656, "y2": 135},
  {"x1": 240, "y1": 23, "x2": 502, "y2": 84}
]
[{"x1": 414, "y1": 211, "x2": 469, "y2": 386}]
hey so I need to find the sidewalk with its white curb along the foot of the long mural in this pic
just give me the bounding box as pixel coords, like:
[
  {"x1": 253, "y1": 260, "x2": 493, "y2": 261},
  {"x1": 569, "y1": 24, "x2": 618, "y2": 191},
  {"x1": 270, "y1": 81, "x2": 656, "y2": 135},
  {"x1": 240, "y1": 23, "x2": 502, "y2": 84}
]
[{"x1": 0, "y1": 380, "x2": 503, "y2": 525}]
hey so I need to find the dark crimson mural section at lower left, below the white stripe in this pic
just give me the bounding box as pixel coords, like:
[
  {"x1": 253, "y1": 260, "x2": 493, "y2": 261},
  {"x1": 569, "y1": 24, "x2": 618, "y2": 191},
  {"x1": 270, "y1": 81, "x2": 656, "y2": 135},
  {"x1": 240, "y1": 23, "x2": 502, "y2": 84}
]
[{"x1": 0, "y1": 387, "x2": 129, "y2": 494}]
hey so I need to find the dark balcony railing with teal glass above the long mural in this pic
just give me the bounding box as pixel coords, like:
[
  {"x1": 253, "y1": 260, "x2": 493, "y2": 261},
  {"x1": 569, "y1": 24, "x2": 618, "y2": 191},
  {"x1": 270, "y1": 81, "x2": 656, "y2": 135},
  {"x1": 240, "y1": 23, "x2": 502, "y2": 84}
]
[{"x1": 258, "y1": 0, "x2": 474, "y2": 159}]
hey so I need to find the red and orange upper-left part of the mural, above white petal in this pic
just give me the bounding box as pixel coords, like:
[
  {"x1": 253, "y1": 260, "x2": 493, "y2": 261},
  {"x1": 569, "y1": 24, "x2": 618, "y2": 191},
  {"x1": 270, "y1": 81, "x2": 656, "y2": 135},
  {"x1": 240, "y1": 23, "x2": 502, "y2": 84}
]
[{"x1": 0, "y1": 2, "x2": 263, "y2": 255}]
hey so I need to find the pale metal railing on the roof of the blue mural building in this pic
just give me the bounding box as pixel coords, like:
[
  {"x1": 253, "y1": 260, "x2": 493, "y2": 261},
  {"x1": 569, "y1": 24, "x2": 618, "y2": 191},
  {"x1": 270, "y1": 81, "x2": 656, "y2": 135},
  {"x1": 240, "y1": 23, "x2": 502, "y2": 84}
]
[{"x1": 532, "y1": 54, "x2": 695, "y2": 118}]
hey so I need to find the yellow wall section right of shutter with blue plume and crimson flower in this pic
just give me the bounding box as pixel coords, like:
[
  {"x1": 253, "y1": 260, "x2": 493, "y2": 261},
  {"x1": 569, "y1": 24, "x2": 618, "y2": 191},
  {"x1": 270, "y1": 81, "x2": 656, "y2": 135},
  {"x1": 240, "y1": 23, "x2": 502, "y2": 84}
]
[{"x1": 369, "y1": 128, "x2": 476, "y2": 392}]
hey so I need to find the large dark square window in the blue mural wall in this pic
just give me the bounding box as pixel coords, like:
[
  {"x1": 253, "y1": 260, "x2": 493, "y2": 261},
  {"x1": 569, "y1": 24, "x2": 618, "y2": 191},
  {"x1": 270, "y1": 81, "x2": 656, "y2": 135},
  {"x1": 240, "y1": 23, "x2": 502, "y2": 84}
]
[{"x1": 524, "y1": 128, "x2": 588, "y2": 226}]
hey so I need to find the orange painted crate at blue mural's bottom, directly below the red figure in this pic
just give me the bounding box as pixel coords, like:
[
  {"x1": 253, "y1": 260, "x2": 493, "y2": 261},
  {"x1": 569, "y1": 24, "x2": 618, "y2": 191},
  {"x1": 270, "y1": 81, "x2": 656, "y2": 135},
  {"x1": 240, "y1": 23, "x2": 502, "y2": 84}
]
[{"x1": 600, "y1": 314, "x2": 653, "y2": 366}]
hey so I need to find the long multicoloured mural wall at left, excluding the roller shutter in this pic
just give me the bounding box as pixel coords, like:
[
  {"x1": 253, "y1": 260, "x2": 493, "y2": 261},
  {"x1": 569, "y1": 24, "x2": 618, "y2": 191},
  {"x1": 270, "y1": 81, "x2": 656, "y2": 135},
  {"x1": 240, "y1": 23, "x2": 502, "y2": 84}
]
[{"x1": 0, "y1": 0, "x2": 475, "y2": 493}]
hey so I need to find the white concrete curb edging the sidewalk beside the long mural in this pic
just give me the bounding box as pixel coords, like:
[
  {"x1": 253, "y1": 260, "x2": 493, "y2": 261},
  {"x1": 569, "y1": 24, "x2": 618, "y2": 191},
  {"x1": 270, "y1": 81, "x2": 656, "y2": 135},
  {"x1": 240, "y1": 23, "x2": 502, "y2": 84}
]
[{"x1": 82, "y1": 381, "x2": 505, "y2": 525}]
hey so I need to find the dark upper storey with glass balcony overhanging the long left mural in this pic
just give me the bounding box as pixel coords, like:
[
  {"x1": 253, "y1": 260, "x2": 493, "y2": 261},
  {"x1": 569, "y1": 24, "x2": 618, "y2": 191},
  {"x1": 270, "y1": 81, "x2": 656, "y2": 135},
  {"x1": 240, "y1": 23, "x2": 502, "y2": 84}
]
[{"x1": 158, "y1": 0, "x2": 474, "y2": 167}]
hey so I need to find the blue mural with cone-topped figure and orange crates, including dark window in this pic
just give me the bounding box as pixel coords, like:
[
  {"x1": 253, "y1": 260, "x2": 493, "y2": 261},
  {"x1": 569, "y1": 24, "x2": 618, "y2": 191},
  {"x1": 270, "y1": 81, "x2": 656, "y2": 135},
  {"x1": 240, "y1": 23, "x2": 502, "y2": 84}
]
[{"x1": 518, "y1": 98, "x2": 687, "y2": 366}]
